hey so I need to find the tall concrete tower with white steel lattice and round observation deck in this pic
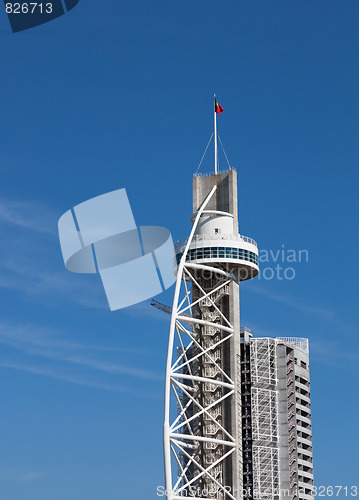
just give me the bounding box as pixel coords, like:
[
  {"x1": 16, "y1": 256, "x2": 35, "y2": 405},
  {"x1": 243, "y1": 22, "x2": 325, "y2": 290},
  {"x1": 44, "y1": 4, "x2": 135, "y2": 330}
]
[{"x1": 164, "y1": 170, "x2": 258, "y2": 500}]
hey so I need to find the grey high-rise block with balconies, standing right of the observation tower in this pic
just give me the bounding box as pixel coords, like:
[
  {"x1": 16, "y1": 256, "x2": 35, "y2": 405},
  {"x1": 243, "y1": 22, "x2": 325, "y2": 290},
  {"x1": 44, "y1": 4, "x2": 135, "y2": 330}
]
[{"x1": 241, "y1": 328, "x2": 313, "y2": 500}]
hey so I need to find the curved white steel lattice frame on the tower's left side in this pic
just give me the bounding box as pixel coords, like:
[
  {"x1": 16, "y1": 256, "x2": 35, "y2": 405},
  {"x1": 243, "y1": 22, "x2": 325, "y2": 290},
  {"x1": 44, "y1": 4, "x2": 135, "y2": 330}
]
[{"x1": 164, "y1": 186, "x2": 236, "y2": 500}]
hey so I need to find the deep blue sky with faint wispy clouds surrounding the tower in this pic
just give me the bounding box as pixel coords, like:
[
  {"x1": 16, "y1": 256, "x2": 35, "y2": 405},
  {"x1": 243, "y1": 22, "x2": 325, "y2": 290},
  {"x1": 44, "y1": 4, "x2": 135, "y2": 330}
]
[{"x1": 0, "y1": 0, "x2": 359, "y2": 500}]
